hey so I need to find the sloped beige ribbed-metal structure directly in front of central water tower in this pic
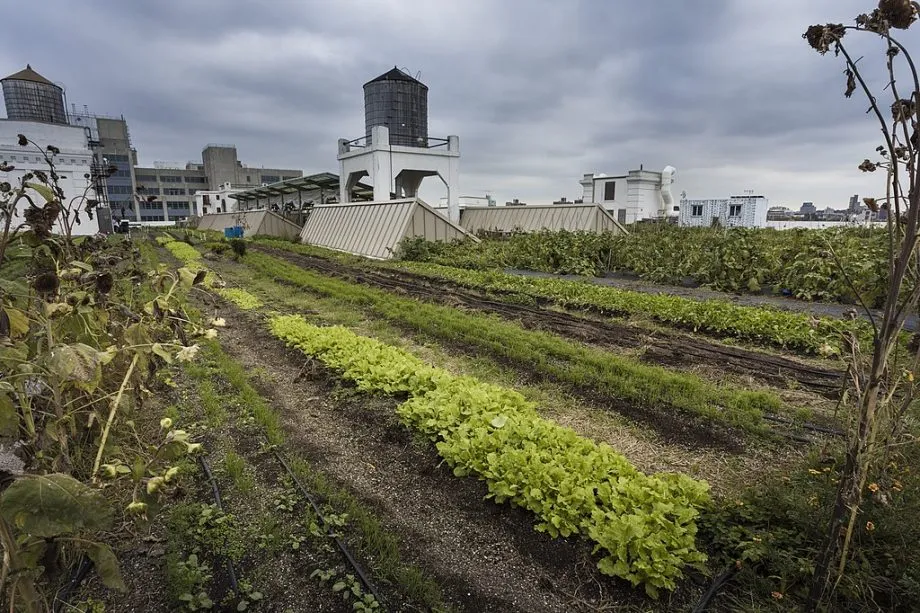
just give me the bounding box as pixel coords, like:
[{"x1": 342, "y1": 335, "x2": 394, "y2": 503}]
[{"x1": 300, "y1": 198, "x2": 478, "y2": 260}]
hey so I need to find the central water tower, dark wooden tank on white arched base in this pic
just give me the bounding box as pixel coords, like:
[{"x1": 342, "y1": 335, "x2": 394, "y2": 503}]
[{"x1": 337, "y1": 67, "x2": 460, "y2": 223}]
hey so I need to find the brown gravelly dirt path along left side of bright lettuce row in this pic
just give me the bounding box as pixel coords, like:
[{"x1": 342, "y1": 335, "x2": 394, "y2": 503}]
[{"x1": 211, "y1": 308, "x2": 668, "y2": 612}]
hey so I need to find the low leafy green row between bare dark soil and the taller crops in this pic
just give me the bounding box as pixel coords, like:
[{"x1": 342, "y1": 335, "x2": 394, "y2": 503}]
[{"x1": 382, "y1": 262, "x2": 871, "y2": 356}]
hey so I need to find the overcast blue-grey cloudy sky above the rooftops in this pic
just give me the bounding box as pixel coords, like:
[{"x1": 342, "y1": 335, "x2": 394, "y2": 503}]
[{"x1": 0, "y1": 0, "x2": 920, "y2": 208}]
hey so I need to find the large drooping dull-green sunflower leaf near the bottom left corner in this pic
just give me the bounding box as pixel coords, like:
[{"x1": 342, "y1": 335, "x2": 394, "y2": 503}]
[{"x1": 0, "y1": 474, "x2": 112, "y2": 538}]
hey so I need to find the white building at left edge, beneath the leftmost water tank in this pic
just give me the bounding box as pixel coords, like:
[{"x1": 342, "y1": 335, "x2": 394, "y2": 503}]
[{"x1": 0, "y1": 119, "x2": 99, "y2": 235}]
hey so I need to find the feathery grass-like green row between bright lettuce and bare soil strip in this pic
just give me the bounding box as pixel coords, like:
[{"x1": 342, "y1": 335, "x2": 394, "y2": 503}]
[{"x1": 244, "y1": 253, "x2": 782, "y2": 431}]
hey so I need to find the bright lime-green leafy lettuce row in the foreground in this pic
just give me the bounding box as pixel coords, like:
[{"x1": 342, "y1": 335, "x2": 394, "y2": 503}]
[{"x1": 270, "y1": 316, "x2": 708, "y2": 596}]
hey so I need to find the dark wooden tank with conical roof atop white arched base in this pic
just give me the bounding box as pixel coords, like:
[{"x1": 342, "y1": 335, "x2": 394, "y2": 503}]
[{"x1": 364, "y1": 66, "x2": 428, "y2": 147}]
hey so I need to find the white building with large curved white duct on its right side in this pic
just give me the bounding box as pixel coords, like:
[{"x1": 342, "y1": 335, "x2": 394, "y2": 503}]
[{"x1": 580, "y1": 166, "x2": 679, "y2": 224}]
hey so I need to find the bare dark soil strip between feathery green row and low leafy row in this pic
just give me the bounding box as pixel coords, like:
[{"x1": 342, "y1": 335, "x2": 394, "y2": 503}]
[{"x1": 253, "y1": 245, "x2": 843, "y2": 397}]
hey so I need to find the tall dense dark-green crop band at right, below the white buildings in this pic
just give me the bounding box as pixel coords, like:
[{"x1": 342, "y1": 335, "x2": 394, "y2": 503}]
[{"x1": 400, "y1": 225, "x2": 888, "y2": 306}]
